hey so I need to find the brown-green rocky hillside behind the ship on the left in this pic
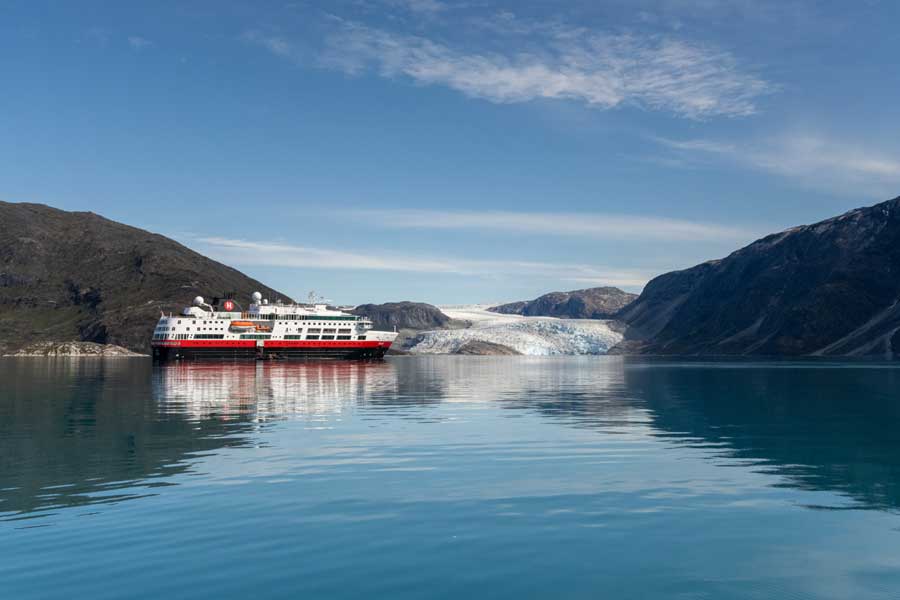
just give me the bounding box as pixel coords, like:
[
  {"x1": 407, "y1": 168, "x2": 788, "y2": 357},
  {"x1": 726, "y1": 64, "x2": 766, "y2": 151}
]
[{"x1": 0, "y1": 202, "x2": 289, "y2": 353}]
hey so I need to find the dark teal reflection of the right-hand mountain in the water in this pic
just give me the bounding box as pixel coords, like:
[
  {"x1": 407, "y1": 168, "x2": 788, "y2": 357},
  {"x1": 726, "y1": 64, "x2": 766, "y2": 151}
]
[{"x1": 624, "y1": 361, "x2": 900, "y2": 510}]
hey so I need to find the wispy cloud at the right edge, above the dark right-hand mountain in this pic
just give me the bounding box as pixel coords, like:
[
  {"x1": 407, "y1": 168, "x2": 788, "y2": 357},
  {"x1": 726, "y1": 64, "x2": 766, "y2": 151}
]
[{"x1": 652, "y1": 134, "x2": 900, "y2": 193}]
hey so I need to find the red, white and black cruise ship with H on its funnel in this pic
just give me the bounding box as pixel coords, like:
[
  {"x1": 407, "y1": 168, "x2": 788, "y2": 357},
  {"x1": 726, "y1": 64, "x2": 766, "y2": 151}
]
[{"x1": 151, "y1": 292, "x2": 397, "y2": 361}]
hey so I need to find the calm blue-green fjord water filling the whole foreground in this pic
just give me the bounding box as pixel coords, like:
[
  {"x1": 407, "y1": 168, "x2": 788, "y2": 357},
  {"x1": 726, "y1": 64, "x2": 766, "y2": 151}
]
[{"x1": 0, "y1": 357, "x2": 900, "y2": 600}]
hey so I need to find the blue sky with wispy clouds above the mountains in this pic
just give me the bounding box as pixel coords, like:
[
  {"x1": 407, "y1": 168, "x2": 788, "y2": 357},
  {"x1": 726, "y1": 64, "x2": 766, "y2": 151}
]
[{"x1": 0, "y1": 0, "x2": 900, "y2": 303}]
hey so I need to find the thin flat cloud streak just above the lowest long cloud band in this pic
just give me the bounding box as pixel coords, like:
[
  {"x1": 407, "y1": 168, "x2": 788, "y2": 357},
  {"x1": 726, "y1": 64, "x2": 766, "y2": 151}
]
[{"x1": 341, "y1": 209, "x2": 755, "y2": 242}]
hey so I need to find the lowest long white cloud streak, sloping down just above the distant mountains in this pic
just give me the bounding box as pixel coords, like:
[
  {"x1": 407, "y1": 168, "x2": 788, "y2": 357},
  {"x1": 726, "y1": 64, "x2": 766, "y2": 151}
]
[{"x1": 196, "y1": 237, "x2": 655, "y2": 287}]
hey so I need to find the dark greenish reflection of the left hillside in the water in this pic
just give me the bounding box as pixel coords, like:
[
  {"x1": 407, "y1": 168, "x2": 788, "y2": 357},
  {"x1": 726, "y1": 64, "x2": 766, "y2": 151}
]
[{"x1": 0, "y1": 359, "x2": 253, "y2": 514}]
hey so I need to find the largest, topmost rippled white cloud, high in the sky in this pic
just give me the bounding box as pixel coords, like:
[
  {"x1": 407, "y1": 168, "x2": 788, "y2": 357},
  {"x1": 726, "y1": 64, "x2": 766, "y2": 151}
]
[{"x1": 242, "y1": 14, "x2": 777, "y2": 119}]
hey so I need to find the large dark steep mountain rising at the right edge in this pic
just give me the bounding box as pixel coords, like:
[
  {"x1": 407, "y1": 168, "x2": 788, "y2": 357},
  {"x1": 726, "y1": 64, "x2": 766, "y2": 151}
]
[{"x1": 618, "y1": 197, "x2": 900, "y2": 356}]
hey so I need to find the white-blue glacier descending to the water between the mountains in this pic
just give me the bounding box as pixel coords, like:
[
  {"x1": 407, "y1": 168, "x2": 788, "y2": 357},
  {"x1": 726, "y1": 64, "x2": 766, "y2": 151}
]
[{"x1": 404, "y1": 305, "x2": 622, "y2": 356}]
